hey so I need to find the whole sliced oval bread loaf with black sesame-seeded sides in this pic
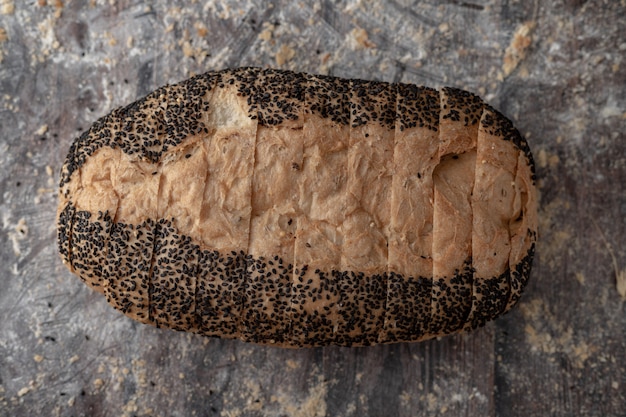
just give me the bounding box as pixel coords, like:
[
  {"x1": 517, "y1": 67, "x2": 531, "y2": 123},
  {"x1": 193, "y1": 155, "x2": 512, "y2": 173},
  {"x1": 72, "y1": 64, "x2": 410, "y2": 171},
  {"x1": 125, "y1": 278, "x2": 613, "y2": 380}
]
[{"x1": 58, "y1": 68, "x2": 537, "y2": 347}]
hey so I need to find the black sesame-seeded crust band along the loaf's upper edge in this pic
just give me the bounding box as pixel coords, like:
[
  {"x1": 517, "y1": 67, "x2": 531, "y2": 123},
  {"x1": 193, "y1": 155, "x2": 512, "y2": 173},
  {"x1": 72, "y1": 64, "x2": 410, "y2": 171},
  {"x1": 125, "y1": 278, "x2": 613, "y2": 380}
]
[{"x1": 60, "y1": 67, "x2": 536, "y2": 187}]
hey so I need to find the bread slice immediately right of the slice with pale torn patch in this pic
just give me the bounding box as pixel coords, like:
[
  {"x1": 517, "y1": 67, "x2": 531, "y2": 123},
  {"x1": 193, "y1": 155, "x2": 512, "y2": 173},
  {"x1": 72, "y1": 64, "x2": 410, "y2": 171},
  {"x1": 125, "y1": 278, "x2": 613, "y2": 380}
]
[{"x1": 240, "y1": 70, "x2": 304, "y2": 344}]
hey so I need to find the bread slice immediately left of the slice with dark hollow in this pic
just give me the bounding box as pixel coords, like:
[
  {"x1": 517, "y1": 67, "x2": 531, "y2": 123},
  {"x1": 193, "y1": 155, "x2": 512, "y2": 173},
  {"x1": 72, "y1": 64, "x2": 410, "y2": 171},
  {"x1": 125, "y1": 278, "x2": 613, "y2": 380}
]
[{"x1": 380, "y1": 84, "x2": 440, "y2": 342}]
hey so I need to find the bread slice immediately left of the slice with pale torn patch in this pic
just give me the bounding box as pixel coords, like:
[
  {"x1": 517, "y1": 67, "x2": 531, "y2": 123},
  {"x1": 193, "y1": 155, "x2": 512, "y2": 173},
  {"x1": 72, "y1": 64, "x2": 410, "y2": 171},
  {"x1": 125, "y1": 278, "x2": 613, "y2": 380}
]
[{"x1": 150, "y1": 77, "x2": 215, "y2": 332}]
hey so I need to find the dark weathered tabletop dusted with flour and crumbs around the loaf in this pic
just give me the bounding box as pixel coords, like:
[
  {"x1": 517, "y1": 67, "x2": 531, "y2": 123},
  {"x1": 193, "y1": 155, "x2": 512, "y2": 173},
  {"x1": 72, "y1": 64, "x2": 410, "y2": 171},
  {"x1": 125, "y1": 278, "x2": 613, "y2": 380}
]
[{"x1": 0, "y1": 0, "x2": 626, "y2": 417}]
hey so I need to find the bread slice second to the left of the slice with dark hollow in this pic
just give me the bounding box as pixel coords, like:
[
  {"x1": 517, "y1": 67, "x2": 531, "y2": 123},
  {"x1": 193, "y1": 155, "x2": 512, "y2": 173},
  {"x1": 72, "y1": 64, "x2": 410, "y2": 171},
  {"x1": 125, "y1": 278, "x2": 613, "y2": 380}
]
[{"x1": 336, "y1": 80, "x2": 396, "y2": 346}]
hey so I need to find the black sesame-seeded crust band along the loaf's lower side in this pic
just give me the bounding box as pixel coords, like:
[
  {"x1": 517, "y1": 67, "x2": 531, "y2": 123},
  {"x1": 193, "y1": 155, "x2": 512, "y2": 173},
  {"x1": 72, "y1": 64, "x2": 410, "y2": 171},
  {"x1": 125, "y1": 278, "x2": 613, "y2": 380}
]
[{"x1": 59, "y1": 203, "x2": 534, "y2": 348}]
